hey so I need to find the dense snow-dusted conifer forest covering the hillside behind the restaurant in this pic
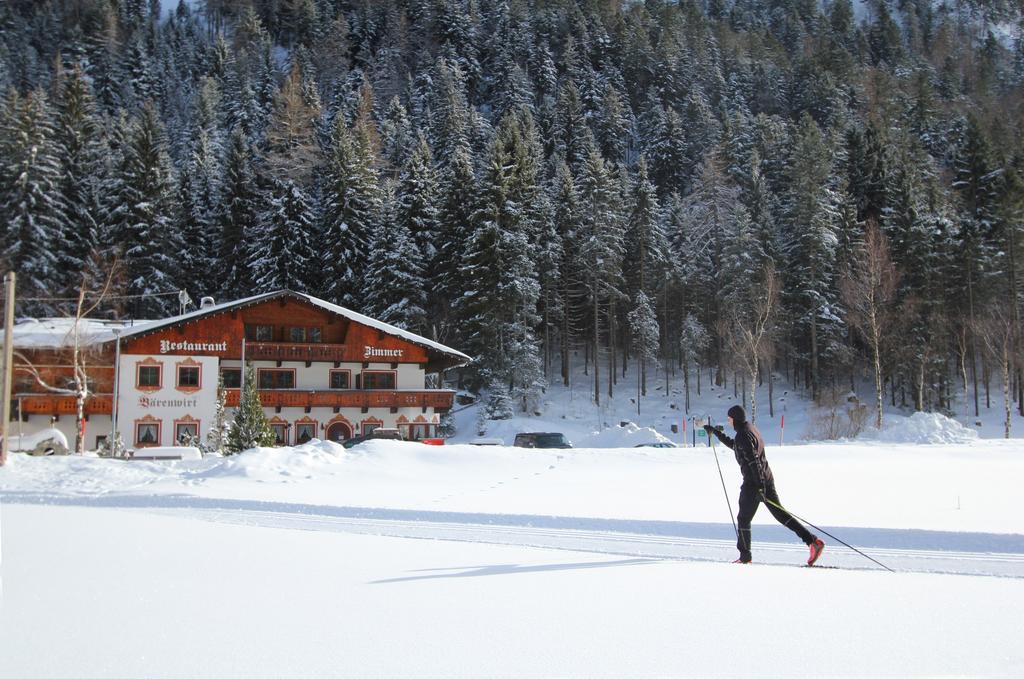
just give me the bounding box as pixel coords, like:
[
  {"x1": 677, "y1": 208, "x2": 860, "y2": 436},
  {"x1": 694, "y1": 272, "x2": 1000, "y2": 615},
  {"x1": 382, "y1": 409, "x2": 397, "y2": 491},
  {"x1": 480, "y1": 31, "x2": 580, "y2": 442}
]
[{"x1": 0, "y1": 0, "x2": 1024, "y2": 426}]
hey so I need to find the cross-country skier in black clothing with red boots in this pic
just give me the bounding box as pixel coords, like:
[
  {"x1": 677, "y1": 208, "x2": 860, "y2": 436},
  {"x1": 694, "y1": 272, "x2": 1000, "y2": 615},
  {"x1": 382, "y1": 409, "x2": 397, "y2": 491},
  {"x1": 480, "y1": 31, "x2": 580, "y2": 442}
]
[{"x1": 705, "y1": 406, "x2": 825, "y2": 565}]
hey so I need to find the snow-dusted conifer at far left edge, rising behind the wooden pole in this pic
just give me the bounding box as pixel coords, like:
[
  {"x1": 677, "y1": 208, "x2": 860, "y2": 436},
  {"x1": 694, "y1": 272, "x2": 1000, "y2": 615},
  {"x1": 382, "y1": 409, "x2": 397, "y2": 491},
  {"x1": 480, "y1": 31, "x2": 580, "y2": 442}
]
[{"x1": 0, "y1": 89, "x2": 66, "y2": 314}]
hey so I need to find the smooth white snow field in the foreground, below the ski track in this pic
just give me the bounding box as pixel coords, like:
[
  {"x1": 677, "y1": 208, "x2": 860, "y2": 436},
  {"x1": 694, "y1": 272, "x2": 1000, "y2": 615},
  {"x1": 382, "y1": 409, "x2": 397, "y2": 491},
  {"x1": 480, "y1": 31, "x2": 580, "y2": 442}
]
[{"x1": 0, "y1": 503, "x2": 1024, "y2": 678}]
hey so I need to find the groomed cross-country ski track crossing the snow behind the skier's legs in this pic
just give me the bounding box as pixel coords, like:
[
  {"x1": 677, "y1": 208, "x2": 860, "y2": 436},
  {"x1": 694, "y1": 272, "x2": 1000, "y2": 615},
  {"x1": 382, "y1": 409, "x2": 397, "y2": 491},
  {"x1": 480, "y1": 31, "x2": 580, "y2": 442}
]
[{"x1": 4, "y1": 493, "x2": 1024, "y2": 579}]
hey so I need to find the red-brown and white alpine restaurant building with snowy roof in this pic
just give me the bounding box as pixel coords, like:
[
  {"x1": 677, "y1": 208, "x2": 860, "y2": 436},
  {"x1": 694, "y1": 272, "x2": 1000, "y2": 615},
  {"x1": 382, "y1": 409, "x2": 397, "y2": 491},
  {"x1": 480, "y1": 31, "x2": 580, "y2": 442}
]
[{"x1": 11, "y1": 290, "x2": 470, "y2": 449}]
